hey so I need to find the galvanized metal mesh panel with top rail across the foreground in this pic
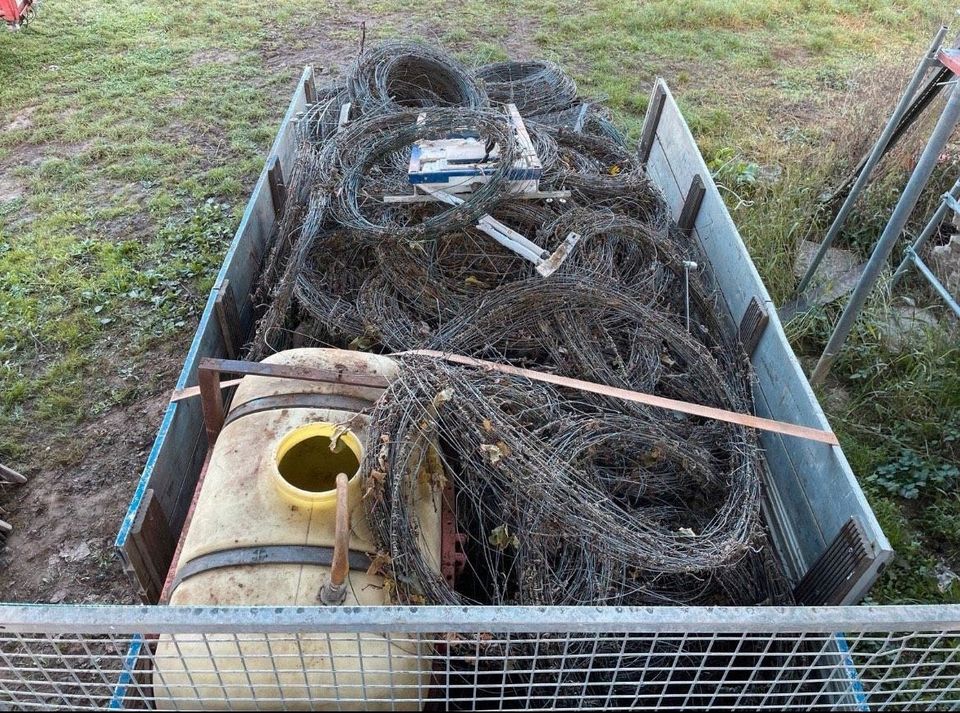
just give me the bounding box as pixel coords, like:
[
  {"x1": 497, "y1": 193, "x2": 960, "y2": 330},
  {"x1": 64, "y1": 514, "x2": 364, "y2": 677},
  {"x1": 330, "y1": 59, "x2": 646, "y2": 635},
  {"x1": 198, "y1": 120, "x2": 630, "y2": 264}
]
[{"x1": 0, "y1": 605, "x2": 960, "y2": 710}]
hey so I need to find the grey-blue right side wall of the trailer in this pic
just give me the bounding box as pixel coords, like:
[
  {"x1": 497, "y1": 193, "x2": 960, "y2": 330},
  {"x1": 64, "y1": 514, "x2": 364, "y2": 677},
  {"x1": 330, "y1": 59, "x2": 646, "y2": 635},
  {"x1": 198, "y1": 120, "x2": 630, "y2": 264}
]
[{"x1": 648, "y1": 82, "x2": 891, "y2": 593}]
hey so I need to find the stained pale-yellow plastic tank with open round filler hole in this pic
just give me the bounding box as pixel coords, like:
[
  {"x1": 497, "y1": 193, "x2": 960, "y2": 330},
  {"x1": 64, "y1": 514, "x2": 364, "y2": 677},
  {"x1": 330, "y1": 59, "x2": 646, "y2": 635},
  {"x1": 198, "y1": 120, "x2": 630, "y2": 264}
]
[{"x1": 153, "y1": 349, "x2": 440, "y2": 710}]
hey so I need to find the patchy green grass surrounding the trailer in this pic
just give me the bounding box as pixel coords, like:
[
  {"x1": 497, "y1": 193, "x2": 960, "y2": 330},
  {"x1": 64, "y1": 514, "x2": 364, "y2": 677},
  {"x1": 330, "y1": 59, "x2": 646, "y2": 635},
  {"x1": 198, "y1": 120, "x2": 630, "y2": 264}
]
[{"x1": 0, "y1": 0, "x2": 960, "y2": 602}]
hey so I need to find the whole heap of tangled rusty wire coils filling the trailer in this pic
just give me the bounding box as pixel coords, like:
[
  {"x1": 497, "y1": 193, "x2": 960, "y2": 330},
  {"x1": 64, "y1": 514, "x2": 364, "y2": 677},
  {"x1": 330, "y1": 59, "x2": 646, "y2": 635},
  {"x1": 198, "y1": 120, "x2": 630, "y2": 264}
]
[{"x1": 247, "y1": 43, "x2": 791, "y2": 605}]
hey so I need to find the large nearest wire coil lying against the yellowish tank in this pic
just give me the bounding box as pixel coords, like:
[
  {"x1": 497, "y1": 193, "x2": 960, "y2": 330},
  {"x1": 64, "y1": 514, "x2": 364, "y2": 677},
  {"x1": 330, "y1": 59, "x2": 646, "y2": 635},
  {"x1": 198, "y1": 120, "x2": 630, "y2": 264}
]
[{"x1": 364, "y1": 357, "x2": 760, "y2": 604}]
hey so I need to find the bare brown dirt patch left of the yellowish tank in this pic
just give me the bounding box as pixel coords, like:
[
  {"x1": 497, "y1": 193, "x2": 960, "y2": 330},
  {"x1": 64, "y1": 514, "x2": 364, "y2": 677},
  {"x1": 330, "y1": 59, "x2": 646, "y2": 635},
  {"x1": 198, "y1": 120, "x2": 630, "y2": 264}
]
[{"x1": 0, "y1": 394, "x2": 168, "y2": 603}]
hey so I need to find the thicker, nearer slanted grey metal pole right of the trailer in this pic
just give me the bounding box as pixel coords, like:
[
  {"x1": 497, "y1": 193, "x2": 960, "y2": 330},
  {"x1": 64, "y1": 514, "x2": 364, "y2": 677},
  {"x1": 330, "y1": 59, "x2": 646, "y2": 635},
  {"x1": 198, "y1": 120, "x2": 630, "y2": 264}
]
[{"x1": 810, "y1": 77, "x2": 960, "y2": 386}]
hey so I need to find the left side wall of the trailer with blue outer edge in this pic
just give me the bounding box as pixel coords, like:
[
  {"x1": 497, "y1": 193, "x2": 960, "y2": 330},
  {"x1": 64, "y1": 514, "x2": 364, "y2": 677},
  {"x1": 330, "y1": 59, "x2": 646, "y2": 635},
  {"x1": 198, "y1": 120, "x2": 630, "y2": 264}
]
[{"x1": 114, "y1": 67, "x2": 313, "y2": 591}]
